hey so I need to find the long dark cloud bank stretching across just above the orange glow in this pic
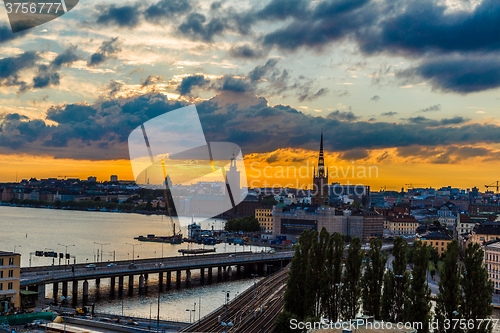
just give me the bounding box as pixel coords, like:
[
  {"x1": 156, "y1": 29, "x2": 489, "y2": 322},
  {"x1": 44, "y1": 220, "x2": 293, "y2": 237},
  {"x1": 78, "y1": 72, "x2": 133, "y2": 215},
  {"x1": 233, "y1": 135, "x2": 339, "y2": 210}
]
[{"x1": 0, "y1": 92, "x2": 500, "y2": 159}]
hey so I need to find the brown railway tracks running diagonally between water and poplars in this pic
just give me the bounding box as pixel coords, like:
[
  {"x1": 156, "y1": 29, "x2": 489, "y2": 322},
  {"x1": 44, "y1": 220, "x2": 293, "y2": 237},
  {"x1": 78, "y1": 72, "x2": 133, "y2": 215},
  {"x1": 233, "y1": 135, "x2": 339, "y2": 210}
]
[{"x1": 183, "y1": 267, "x2": 289, "y2": 333}]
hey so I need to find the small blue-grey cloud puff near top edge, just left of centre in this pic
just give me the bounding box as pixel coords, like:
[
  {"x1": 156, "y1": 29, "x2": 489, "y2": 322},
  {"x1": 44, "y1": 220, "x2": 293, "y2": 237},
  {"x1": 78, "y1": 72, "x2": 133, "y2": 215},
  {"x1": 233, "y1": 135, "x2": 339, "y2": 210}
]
[{"x1": 178, "y1": 13, "x2": 226, "y2": 42}]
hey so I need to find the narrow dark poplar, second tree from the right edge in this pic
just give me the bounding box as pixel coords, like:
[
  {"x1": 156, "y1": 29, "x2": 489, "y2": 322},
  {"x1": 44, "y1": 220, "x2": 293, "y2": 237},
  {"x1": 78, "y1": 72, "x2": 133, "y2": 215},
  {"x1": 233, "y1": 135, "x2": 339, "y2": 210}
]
[{"x1": 435, "y1": 239, "x2": 461, "y2": 333}]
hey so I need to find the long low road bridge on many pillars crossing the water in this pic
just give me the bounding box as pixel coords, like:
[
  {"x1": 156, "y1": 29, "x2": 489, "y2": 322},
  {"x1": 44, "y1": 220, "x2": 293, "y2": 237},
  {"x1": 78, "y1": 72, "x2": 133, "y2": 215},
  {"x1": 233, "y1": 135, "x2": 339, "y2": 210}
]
[{"x1": 20, "y1": 251, "x2": 294, "y2": 305}]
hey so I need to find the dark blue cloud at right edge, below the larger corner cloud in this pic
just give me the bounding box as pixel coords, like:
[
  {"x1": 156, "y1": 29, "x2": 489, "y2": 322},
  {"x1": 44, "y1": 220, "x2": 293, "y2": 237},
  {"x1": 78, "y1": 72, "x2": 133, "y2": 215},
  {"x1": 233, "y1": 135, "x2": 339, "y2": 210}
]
[{"x1": 396, "y1": 56, "x2": 500, "y2": 94}]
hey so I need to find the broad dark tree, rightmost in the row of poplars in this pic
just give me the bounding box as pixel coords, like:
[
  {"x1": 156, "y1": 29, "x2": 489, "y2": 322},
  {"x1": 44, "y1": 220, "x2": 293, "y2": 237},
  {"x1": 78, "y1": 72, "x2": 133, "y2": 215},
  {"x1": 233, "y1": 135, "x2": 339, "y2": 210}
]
[{"x1": 460, "y1": 243, "x2": 493, "y2": 333}]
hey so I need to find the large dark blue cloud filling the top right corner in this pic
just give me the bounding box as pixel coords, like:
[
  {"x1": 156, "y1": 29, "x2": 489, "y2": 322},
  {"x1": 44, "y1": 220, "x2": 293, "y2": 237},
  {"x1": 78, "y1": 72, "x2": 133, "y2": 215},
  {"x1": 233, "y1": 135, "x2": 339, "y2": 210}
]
[{"x1": 358, "y1": 0, "x2": 500, "y2": 56}]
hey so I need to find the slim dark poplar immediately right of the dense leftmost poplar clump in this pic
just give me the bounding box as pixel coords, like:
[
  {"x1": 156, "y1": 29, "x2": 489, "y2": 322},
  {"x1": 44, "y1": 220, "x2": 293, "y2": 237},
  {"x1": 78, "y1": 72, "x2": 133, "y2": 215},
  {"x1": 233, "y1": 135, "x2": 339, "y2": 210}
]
[{"x1": 342, "y1": 237, "x2": 365, "y2": 320}]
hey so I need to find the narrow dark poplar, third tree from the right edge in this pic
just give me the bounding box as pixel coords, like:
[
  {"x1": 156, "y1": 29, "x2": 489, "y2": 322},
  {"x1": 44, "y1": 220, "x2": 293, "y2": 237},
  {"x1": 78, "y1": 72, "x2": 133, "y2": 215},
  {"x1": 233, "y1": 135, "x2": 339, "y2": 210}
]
[{"x1": 405, "y1": 240, "x2": 431, "y2": 332}]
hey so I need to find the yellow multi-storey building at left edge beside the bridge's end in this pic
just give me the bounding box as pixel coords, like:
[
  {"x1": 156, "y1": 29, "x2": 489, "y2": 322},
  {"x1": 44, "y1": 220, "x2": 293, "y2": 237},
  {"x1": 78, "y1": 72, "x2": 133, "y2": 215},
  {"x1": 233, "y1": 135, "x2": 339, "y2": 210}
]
[{"x1": 0, "y1": 251, "x2": 21, "y2": 312}]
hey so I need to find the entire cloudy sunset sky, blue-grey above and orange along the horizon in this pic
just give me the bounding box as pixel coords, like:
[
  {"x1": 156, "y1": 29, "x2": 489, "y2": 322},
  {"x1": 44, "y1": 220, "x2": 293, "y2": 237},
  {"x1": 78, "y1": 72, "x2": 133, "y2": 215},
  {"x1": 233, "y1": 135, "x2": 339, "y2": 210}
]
[{"x1": 0, "y1": 0, "x2": 500, "y2": 190}]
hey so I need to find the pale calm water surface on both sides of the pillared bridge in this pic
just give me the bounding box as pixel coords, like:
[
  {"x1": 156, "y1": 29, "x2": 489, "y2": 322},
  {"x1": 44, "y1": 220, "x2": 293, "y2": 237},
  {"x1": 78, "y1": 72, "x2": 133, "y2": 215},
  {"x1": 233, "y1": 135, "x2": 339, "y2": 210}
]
[{"x1": 0, "y1": 206, "x2": 268, "y2": 322}]
